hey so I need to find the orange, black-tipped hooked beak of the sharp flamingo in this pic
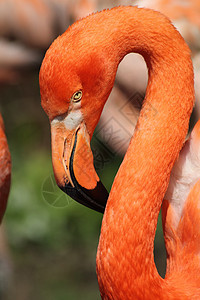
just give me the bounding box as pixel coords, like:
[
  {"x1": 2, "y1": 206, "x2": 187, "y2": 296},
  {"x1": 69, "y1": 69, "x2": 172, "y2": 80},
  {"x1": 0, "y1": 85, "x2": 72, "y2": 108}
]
[{"x1": 51, "y1": 123, "x2": 108, "y2": 213}]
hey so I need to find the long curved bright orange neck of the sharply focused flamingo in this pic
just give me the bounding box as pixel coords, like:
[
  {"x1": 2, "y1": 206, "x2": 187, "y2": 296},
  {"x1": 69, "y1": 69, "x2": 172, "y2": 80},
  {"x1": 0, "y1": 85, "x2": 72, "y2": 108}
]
[{"x1": 97, "y1": 7, "x2": 194, "y2": 299}]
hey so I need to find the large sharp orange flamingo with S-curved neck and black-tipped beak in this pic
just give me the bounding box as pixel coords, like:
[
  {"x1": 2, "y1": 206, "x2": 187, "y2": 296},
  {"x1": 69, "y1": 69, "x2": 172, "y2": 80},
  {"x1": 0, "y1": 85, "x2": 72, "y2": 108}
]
[{"x1": 39, "y1": 6, "x2": 200, "y2": 300}]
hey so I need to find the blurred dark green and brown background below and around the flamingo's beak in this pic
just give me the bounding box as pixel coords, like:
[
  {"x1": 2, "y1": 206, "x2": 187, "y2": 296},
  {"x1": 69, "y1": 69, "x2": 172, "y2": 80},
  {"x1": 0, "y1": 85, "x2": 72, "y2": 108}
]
[{"x1": 0, "y1": 69, "x2": 165, "y2": 300}]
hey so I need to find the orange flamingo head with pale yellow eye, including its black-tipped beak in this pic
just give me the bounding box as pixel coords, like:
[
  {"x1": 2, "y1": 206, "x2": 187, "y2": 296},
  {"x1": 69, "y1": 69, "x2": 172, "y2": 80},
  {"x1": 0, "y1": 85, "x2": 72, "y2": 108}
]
[{"x1": 39, "y1": 25, "x2": 117, "y2": 212}]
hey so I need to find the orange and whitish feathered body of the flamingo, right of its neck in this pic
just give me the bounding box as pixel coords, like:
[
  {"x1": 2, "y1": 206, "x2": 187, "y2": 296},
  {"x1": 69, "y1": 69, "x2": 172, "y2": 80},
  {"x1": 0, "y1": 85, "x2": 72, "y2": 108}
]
[{"x1": 162, "y1": 120, "x2": 200, "y2": 289}]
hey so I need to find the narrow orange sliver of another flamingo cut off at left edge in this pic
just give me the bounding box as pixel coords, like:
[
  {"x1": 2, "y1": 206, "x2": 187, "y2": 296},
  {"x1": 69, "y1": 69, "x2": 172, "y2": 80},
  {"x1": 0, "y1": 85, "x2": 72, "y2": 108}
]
[{"x1": 0, "y1": 114, "x2": 11, "y2": 222}]
